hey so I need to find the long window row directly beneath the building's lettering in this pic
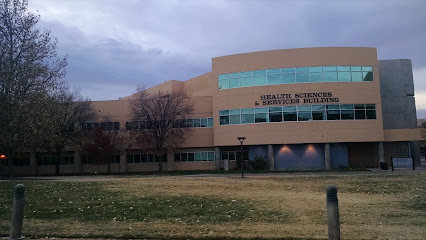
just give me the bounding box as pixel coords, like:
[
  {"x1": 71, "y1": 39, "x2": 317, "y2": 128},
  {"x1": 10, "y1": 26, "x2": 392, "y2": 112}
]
[{"x1": 219, "y1": 104, "x2": 376, "y2": 125}]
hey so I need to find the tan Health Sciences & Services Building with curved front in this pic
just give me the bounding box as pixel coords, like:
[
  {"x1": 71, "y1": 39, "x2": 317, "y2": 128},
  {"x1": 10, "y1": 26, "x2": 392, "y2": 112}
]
[{"x1": 9, "y1": 47, "x2": 421, "y2": 174}]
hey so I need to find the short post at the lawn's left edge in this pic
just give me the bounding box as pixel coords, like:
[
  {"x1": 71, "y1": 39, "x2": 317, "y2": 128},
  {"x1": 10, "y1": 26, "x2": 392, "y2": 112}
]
[{"x1": 9, "y1": 184, "x2": 25, "y2": 240}]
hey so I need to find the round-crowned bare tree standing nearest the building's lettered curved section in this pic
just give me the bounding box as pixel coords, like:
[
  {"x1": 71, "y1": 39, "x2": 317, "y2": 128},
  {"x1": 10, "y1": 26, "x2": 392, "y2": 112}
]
[{"x1": 131, "y1": 87, "x2": 194, "y2": 173}]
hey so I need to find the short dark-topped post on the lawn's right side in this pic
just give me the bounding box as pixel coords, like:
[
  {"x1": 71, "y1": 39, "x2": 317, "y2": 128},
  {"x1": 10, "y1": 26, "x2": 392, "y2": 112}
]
[{"x1": 325, "y1": 185, "x2": 340, "y2": 240}]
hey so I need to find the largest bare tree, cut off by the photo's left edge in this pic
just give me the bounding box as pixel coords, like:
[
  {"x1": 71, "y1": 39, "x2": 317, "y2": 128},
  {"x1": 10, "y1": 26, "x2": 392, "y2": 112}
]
[{"x1": 0, "y1": 0, "x2": 67, "y2": 176}]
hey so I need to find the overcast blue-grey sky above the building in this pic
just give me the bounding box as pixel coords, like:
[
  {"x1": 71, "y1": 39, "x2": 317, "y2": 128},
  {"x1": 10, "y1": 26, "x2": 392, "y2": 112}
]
[{"x1": 29, "y1": 0, "x2": 426, "y2": 117}]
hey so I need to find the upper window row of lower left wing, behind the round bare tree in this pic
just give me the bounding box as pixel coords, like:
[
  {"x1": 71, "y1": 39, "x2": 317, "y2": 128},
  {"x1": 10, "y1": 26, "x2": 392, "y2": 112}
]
[{"x1": 126, "y1": 118, "x2": 213, "y2": 130}]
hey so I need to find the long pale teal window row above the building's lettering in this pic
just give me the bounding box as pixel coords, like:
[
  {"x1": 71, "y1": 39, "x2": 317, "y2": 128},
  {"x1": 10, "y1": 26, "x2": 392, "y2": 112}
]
[{"x1": 218, "y1": 66, "x2": 373, "y2": 89}]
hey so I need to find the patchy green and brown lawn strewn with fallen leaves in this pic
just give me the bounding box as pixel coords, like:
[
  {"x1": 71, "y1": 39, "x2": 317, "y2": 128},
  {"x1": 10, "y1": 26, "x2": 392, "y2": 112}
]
[{"x1": 0, "y1": 172, "x2": 426, "y2": 239}]
